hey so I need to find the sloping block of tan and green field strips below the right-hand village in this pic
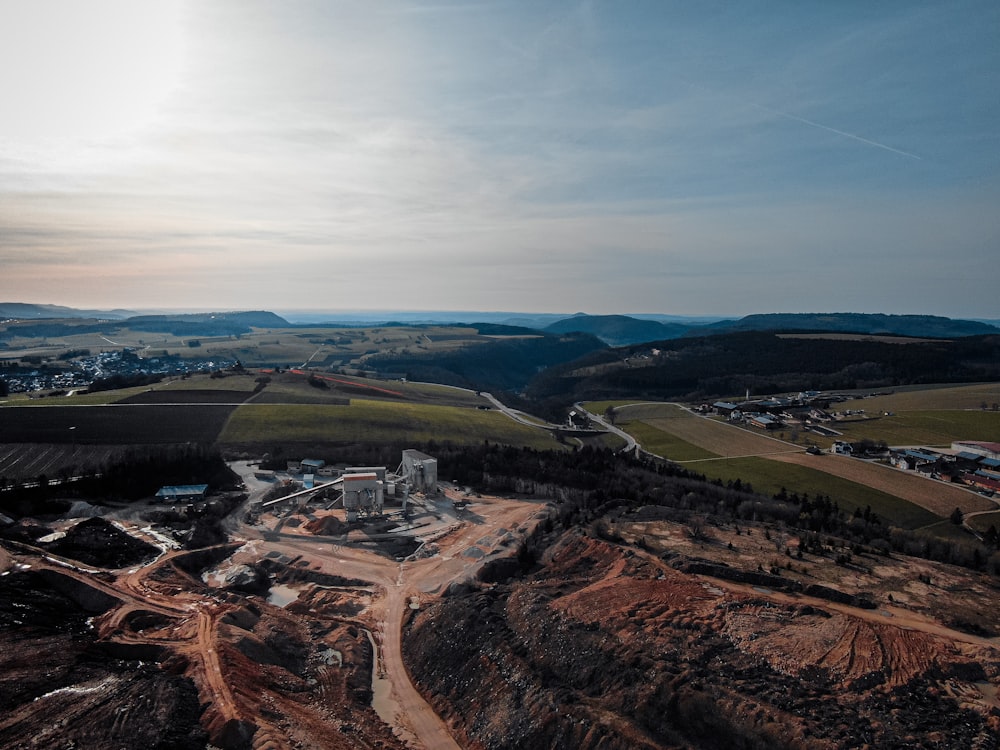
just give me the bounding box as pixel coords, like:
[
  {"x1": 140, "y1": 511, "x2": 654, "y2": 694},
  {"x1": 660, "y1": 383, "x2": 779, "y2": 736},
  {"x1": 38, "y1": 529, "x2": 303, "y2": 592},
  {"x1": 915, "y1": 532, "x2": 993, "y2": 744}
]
[{"x1": 591, "y1": 403, "x2": 996, "y2": 528}]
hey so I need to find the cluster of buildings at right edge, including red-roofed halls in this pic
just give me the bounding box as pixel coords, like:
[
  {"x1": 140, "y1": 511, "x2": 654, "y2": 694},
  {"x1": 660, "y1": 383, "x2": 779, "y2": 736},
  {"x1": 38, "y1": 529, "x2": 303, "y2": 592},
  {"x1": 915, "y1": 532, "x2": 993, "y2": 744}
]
[{"x1": 889, "y1": 441, "x2": 1000, "y2": 494}]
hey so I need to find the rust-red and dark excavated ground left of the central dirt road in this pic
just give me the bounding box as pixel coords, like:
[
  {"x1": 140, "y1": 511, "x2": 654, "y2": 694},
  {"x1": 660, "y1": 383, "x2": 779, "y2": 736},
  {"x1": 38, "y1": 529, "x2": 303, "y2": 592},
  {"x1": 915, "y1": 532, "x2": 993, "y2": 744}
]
[{"x1": 0, "y1": 523, "x2": 404, "y2": 750}]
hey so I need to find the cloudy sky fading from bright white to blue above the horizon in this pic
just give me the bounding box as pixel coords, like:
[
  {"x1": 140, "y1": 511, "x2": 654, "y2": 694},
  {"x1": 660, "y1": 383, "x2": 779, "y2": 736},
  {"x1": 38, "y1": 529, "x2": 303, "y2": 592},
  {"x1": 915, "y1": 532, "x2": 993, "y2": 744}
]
[{"x1": 0, "y1": 0, "x2": 1000, "y2": 319}]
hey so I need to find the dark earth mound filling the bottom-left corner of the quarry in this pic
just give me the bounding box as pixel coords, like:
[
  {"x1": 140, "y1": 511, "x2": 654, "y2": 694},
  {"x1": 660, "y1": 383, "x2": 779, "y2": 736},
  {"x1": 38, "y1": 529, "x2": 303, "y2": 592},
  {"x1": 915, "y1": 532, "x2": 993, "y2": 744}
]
[{"x1": 0, "y1": 570, "x2": 208, "y2": 750}]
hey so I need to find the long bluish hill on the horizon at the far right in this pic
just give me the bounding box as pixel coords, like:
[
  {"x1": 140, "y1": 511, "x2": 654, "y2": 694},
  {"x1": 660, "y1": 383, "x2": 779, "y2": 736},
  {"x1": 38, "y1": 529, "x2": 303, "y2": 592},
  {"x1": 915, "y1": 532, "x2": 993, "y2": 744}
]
[{"x1": 700, "y1": 313, "x2": 1000, "y2": 339}]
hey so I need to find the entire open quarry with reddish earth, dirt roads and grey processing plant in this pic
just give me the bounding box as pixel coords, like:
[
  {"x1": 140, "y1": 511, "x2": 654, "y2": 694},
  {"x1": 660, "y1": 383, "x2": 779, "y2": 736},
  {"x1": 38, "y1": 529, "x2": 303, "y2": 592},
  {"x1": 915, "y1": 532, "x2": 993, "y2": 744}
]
[{"x1": 0, "y1": 451, "x2": 1000, "y2": 749}]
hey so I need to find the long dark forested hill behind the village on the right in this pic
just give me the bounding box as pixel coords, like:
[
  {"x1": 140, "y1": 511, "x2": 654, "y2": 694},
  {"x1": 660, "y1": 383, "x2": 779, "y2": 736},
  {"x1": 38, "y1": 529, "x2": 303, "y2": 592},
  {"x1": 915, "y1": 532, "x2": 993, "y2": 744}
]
[{"x1": 526, "y1": 332, "x2": 1000, "y2": 408}]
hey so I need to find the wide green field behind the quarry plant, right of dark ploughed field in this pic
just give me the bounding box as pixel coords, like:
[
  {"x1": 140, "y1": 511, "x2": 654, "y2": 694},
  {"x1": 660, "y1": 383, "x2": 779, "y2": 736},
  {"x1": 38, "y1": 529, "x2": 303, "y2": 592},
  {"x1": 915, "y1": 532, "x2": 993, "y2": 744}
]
[{"x1": 219, "y1": 399, "x2": 558, "y2": 449}]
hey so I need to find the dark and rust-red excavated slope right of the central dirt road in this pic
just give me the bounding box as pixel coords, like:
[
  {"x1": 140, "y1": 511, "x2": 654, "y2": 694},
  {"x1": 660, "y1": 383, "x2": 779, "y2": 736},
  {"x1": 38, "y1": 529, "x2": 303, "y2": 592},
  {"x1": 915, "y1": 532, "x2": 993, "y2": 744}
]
[{"x1": 404, "y1": 531, "x2": 1000, "y2": 750}]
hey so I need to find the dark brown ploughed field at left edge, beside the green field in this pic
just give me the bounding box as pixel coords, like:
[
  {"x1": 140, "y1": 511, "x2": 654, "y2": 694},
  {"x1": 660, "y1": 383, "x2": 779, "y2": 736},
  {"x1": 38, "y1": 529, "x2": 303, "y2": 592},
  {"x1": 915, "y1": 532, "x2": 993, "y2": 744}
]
[{"x1": 0, "y1": 404, "x2": 236, "y2": 445}]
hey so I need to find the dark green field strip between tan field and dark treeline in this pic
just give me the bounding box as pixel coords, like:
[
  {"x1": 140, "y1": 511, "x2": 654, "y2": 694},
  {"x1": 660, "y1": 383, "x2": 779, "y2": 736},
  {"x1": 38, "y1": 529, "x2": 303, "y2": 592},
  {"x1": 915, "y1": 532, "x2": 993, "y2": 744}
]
[{"x1": 684, "y1": 458, "x2": 941, "y2": 529}]
